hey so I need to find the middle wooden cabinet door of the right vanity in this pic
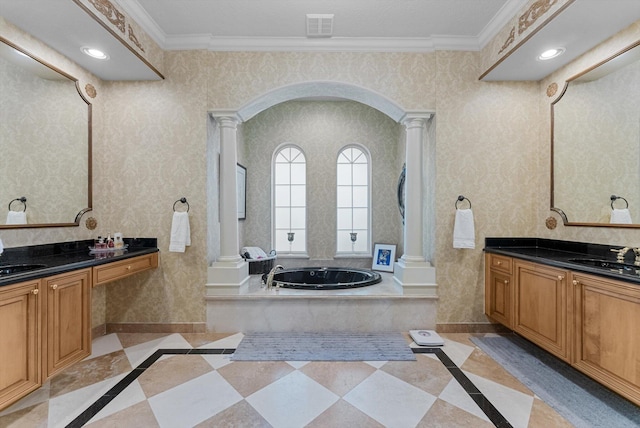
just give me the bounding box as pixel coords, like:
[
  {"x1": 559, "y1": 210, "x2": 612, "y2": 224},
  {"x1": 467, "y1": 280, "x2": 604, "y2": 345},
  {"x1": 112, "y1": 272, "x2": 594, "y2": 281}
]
[{"x1": 514, "y1": 261, "x2": 569, "y2": 361}]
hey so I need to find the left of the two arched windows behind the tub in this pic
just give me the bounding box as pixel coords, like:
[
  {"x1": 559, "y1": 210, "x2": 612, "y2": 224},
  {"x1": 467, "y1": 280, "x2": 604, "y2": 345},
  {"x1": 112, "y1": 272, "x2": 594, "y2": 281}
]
[{"x1": 272, "y1": 145, "x2": 307, "y2": 254}]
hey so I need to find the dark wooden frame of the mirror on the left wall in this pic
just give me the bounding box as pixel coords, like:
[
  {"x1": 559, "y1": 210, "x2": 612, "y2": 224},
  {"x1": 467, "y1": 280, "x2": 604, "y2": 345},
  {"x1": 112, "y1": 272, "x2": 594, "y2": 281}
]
[{"x1": 0, "y1": 36, "x2": 93, "y2": 229}]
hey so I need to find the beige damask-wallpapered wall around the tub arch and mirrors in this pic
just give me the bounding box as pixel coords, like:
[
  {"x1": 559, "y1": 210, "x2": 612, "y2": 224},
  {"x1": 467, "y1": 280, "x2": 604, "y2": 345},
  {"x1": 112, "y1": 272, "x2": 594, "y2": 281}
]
[{"x1": 5, "y1": 13, "x2": 640, "y2": 325}]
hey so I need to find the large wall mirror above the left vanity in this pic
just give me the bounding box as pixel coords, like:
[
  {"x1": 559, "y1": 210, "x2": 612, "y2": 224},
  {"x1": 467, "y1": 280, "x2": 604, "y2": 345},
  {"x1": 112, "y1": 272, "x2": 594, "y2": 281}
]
[{"x1": 0, "y1": 37, "x2": 91, "y2": 228}]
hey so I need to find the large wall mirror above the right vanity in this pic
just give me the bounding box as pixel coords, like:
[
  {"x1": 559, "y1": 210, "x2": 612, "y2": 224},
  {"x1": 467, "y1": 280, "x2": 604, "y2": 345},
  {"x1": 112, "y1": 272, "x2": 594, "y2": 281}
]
[{"x1": 551, "y1": 42, "x2": 640, "y2": 227}]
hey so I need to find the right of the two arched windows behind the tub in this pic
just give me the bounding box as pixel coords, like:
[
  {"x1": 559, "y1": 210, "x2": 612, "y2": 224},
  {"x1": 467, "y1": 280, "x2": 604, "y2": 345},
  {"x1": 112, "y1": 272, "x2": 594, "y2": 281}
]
[{"x1": 336, "y1": 146, "x2": 371, "y2": 255}]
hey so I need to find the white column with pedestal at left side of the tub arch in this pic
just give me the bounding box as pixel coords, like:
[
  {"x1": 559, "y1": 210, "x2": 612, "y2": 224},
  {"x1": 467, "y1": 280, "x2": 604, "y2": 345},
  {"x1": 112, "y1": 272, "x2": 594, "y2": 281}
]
[{"x1": 207, "y1": 113, "x2": 249, "y2": 295}]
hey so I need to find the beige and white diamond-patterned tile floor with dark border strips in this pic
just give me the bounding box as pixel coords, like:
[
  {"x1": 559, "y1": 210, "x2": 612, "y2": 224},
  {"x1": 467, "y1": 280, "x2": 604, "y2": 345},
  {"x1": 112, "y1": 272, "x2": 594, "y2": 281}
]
[{"x1": 0, "y1": 333, "x2": 571, "y2": 428}]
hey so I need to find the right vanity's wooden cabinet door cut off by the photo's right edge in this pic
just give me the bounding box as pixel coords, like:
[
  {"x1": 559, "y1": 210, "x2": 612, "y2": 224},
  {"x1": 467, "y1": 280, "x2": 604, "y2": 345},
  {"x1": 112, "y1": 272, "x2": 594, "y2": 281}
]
[{"x1": 573, "y1": 273, "x2": 640, "y2": 405}]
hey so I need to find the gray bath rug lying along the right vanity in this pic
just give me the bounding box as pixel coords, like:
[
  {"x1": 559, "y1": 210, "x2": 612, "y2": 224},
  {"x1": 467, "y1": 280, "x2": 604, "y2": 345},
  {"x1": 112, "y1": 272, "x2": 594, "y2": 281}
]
[{"x1": 471, "y1": 335, "x2": 640, "y2": 428}]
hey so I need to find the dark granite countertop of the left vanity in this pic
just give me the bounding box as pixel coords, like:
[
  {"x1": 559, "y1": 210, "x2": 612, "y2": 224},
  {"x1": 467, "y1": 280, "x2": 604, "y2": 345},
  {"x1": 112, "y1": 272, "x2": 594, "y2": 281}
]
[{"x1": 0, "y1": 238, "x2": 159, "y2": 287}]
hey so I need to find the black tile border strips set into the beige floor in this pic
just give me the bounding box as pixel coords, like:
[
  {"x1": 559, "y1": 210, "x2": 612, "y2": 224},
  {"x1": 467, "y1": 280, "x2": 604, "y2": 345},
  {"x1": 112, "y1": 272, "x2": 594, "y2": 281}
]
[{"x1": 66, "y1": 348, "x2": 512, "y2": 428}]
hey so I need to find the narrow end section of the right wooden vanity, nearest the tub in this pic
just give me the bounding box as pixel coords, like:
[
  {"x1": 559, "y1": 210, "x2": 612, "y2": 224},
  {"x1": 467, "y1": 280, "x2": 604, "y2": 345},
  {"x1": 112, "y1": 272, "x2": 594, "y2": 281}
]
[{"x1": 484, "y1": 253, "x2": 513, "y2": 329}]
